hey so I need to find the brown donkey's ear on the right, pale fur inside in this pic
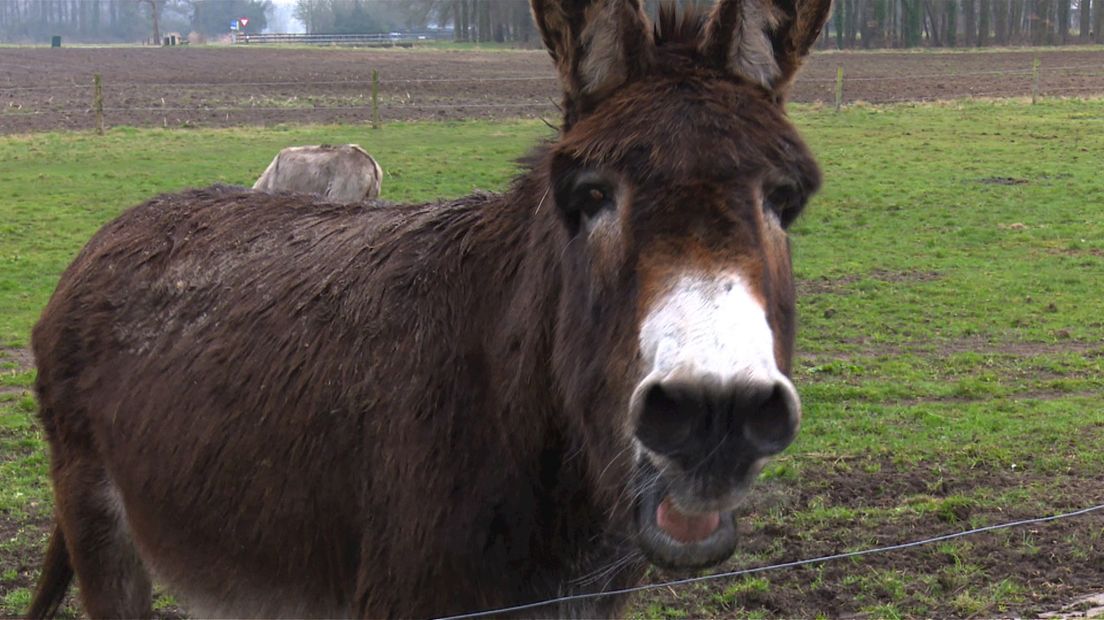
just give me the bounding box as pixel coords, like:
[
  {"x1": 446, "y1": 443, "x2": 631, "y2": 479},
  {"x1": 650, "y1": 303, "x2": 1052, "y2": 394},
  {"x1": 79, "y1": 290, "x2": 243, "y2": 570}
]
[{"x1": 701, "y1": 0, "x2": 831, "y2": 95}]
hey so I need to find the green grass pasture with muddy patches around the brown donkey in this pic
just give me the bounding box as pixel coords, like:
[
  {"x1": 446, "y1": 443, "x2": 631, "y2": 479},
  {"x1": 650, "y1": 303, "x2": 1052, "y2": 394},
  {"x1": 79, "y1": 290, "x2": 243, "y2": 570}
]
[{"x1": 0, "y1": 100, "x2": 1104, "y2": 618}]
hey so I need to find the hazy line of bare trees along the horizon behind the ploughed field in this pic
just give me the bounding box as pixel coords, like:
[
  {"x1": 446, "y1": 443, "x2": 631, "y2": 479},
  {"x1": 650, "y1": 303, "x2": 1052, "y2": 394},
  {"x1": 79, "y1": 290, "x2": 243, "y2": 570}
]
[{"x1": 0, "y1": 0, "x2": 1104, "y2": 49}]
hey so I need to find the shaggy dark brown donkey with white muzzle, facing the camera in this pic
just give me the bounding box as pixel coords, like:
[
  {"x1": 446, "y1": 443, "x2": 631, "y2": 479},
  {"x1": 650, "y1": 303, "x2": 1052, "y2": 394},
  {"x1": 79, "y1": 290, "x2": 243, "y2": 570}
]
[{"x1": 30, "y1": 0, "x2": 829, "y2": 618}]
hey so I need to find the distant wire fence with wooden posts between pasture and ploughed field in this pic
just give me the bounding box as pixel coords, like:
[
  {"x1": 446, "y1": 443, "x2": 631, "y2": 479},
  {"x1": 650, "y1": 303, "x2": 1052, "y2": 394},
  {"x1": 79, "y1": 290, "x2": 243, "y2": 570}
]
[{"x1": 0, "y1": 61, "x2": 1104, "y2": 132}]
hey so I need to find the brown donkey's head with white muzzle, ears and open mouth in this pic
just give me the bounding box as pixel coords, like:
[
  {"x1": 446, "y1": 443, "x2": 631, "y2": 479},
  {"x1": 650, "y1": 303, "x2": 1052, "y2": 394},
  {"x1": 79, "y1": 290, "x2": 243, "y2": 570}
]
[{"x1": 532, "y1": 0, "x2": 830, "y2": 567}]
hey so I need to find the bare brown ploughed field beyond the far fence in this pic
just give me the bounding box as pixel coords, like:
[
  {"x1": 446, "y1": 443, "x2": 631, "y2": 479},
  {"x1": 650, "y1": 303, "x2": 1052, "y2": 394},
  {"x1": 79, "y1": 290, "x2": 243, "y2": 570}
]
[{"x1": 0, "y1": 47, "x2": 1104, "y2": 133}]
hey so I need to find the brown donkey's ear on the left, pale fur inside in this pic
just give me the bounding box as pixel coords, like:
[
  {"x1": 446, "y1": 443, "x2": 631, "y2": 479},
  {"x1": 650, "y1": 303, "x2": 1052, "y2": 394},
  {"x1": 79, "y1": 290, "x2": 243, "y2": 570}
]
[{"x1": 531, "y1": 0, "x2": 652, "y2": 117}]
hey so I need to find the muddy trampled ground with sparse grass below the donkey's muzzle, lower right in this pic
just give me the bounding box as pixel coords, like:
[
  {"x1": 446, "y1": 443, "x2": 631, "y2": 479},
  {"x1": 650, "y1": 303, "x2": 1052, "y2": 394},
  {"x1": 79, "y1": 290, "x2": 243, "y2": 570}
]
[{"x1": 638, "y1": 456, "x2": 1104, "y2": 618}]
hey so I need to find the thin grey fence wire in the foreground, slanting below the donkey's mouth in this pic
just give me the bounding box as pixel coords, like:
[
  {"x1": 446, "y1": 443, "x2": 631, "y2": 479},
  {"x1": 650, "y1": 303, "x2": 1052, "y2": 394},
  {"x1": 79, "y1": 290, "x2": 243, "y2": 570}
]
[{"x1": 437, "y1": 504, "x2": 1104, "y2": 620}]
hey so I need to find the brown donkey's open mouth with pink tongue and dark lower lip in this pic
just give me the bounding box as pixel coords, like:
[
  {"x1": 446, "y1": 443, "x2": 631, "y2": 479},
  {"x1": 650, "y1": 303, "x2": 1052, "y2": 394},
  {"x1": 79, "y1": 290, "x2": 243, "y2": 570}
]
[{"x1": 636, "y1": 459, "x2": 743, "y2": 569}]
